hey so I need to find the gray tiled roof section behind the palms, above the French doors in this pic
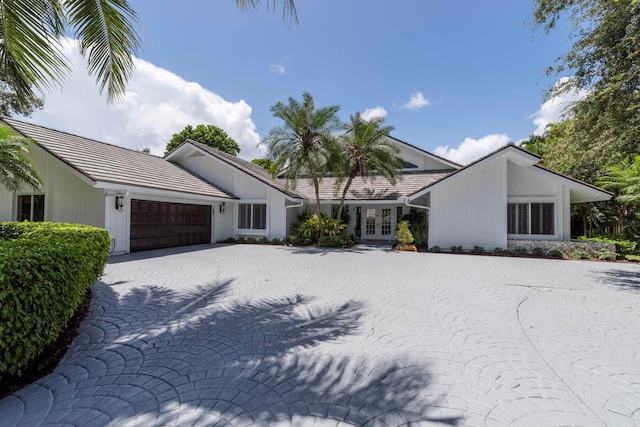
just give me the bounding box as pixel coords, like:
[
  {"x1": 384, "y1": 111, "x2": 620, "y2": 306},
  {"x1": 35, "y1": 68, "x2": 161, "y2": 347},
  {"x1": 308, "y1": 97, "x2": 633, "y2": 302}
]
[{"x1": 296, "y1": 170, "x2": 453, "y2": 200}]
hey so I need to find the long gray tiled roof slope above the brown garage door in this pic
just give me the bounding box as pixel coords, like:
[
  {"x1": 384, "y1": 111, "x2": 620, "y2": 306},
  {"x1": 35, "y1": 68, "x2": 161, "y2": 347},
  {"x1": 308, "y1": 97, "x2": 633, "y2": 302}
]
[{"x1": 1, "y1": 118, "x2": 235, "y2": 198}]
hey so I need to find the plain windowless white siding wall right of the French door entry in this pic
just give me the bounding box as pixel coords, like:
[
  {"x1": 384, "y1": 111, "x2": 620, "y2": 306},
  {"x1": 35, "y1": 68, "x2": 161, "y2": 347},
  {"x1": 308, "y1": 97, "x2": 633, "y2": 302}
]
[{"x1": 429, "y1": 158, "x2": 507, "y2": 250}]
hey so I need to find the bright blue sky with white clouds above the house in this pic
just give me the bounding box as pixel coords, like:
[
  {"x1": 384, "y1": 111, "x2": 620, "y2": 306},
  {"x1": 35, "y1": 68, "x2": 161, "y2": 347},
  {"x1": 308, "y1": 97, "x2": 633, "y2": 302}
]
[{"x1": 32, "y1": 0, "x2": 580, "y2": 163}]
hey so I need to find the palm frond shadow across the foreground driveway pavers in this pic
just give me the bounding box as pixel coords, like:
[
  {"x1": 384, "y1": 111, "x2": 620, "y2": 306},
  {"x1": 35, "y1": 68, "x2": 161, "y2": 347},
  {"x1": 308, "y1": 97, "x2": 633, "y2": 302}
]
[{"x1": 0, "y1": 281, "x2": 460, "y2": 426}]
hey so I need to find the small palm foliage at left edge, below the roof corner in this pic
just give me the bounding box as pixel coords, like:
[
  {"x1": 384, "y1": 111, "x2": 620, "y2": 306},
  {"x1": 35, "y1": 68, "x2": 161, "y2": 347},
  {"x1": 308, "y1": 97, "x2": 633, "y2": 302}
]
[{"x1": 0, "y1": 126, "x2": 42, "y2": 193}]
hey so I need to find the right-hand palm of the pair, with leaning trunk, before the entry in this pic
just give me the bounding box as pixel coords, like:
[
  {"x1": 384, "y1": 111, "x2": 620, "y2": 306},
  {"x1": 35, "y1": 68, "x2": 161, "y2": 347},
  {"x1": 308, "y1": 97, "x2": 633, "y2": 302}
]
[{"x1": 336, "y1": 113, "x2": 403, "y2": 219}]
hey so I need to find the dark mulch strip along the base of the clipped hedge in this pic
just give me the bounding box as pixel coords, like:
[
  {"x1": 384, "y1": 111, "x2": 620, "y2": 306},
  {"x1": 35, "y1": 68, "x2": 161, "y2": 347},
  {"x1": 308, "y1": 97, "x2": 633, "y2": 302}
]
[{"x1": 0, "y1": 288, "x2": 92, "y2": 399}]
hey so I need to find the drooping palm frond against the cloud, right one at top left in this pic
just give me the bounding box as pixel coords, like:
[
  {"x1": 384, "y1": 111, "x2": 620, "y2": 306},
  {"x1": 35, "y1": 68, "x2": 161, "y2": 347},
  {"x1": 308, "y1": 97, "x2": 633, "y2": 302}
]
[{"x1": 64, "y1": 0, "x2": 140, "y2": 102}]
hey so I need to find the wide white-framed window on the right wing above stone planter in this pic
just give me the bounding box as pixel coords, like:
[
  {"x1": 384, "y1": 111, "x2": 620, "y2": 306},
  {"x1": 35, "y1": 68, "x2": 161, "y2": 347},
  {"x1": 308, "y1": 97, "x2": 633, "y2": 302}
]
[{"x1": 507, "y1": 203, "x2": 555, "y2": 235}]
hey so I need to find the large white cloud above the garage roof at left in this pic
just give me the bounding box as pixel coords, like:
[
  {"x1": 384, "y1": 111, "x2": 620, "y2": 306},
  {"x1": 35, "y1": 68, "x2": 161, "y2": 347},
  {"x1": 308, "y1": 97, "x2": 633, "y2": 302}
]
[{"x1": 33, "y1": 40, "x2": 264, "y2": 159}]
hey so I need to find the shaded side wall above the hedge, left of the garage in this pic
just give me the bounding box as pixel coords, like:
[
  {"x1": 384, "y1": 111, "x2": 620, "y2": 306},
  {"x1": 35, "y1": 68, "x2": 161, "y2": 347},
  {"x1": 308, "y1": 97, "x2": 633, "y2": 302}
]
[{"x1": 0, "y1": 144, "x2": 105, "y2": 228}]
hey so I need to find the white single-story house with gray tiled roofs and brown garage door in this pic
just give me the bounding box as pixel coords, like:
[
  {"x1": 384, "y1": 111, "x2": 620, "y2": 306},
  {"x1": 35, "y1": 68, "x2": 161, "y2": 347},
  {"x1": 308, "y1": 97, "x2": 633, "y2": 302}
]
[{"x1": 0, "y1": 118, "x2": 611, "y2": 253}]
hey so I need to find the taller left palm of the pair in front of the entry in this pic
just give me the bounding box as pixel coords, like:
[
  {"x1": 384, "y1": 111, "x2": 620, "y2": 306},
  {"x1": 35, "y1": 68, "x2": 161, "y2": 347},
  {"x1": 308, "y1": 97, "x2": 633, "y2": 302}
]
[{"x1": 263, "y1": 92, "x2": 344, "y2": 237}]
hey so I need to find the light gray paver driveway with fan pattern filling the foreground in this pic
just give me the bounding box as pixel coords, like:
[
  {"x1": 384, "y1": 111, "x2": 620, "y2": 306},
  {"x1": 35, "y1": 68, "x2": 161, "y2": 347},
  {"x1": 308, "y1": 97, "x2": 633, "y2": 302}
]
[{"x1": 0, "y1": 245, "x2": 640, "y2": 426}]
